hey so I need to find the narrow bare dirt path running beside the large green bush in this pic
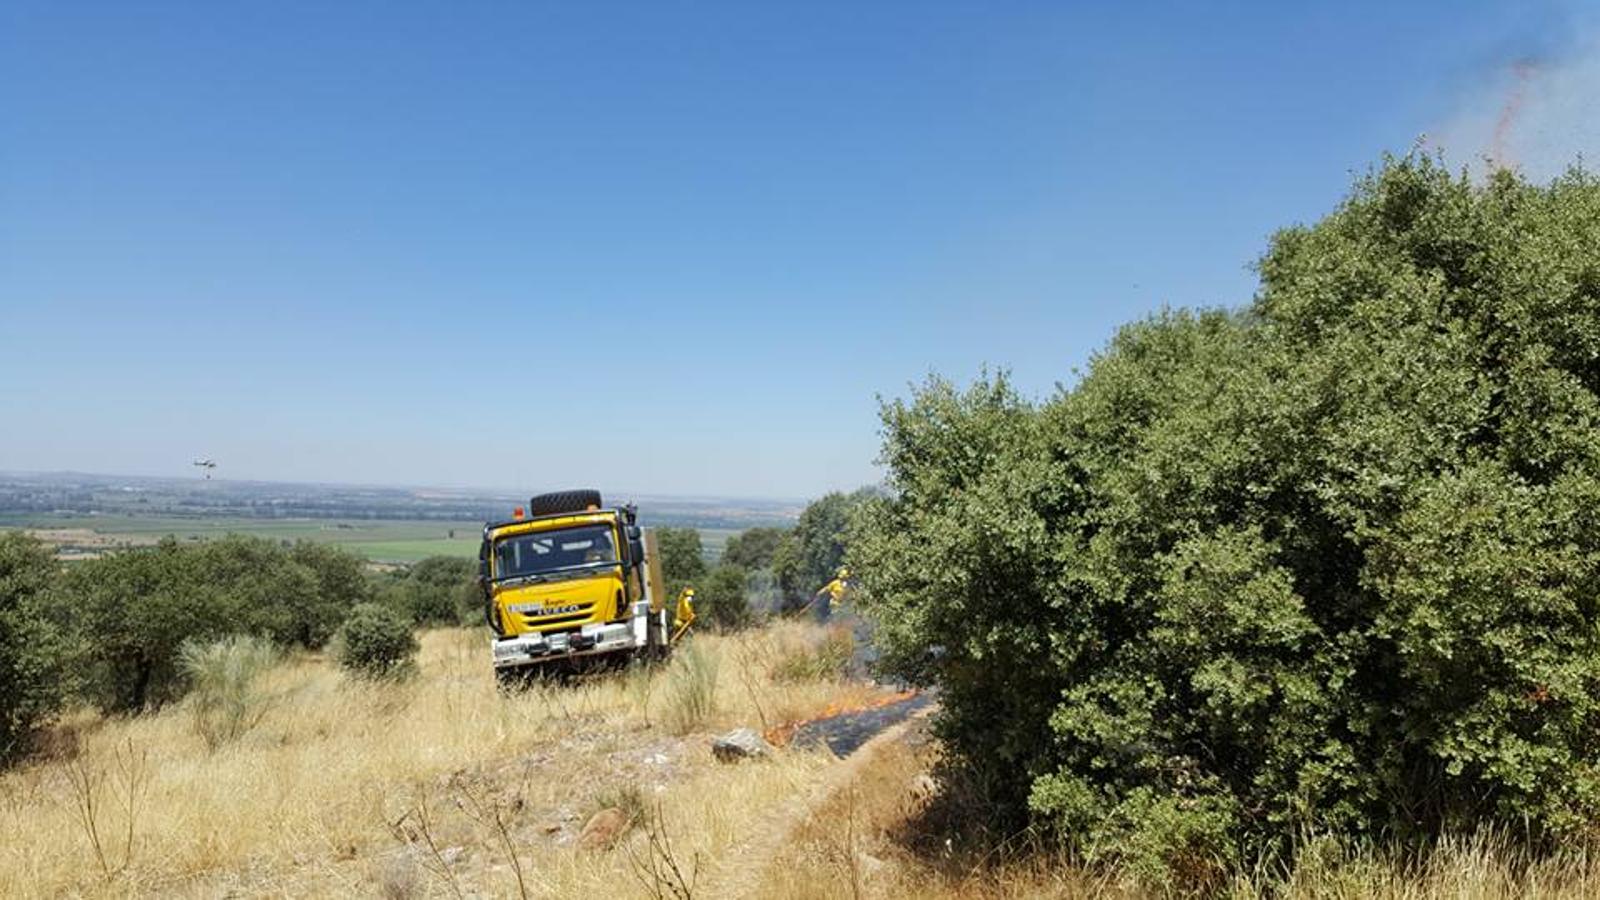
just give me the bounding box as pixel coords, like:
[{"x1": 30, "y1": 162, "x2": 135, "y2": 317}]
[{"x1": 694, "y1": 698, "x2": 936, "y2": 898}]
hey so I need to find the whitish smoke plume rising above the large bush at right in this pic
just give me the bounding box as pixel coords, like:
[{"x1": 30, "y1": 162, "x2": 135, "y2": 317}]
[{"x1": 1424, "y1": 38, "x2": 1600, "y2": 181}]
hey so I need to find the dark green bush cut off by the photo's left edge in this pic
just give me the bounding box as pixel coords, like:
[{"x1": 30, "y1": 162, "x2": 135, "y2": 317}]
[{"x1": 0, "y1": 532, "x2": 72, "y2": 762}]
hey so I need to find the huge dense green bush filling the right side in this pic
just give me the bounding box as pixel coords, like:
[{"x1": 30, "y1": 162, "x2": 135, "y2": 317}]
[{"x1": 853, "y1": 159, "x2": 1600, "y2": 882}]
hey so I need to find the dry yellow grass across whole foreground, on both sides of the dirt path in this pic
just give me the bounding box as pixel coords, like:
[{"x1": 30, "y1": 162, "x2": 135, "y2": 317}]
[{"x1": 12, "y1": 623, "x2": 1600, "y2": 900}]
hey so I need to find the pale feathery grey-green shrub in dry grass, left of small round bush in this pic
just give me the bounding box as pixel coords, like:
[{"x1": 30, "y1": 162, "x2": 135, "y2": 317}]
[{"x1": 179, "y1": 634, "x2": 278, "y2": 749}]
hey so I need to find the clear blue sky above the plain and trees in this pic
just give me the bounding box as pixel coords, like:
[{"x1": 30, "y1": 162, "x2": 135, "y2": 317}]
[{"x1": 0, "y1": 0, "x2": 1590, "y2": 496}]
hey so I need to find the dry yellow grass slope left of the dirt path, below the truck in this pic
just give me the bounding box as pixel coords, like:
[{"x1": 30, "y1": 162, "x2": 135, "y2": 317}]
[{"x1": 0, "y1": 625, "x2": 889, "y2": 897}]
